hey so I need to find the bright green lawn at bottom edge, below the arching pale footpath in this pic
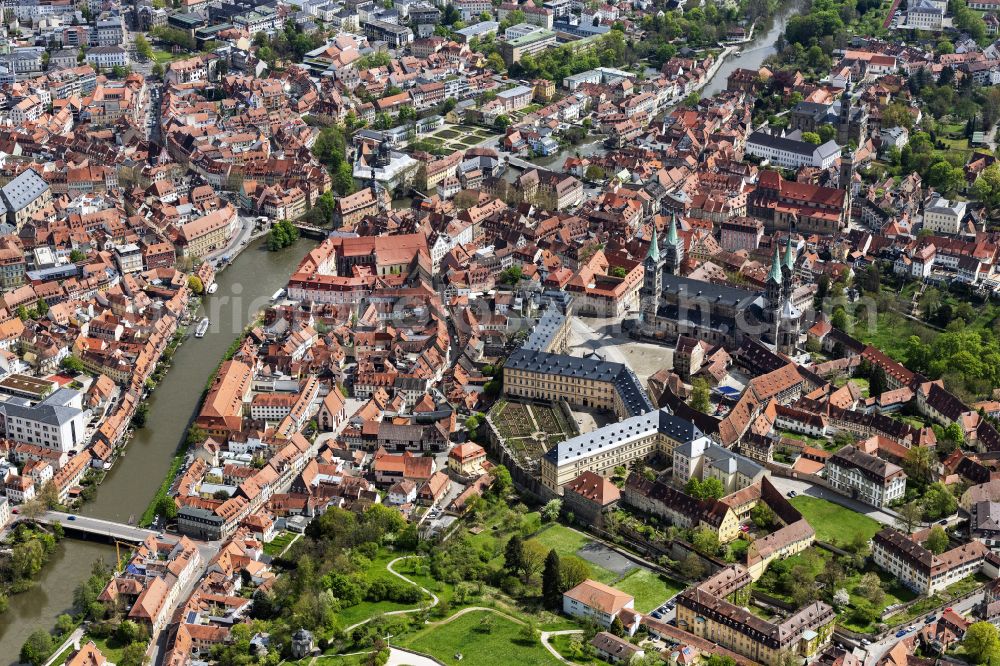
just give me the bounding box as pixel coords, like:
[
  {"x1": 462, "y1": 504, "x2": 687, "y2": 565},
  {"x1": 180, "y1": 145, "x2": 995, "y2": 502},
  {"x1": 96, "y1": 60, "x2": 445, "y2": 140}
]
[{"x1": 401, "y1": 611, "x2": 562, "y2": 666}]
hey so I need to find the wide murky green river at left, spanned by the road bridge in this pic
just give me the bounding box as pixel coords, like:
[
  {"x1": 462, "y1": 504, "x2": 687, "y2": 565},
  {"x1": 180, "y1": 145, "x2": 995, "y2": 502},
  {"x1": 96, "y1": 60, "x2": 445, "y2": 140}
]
[{"x1": 0, "y1": 239, "x2": 315, "y2": 666}]
